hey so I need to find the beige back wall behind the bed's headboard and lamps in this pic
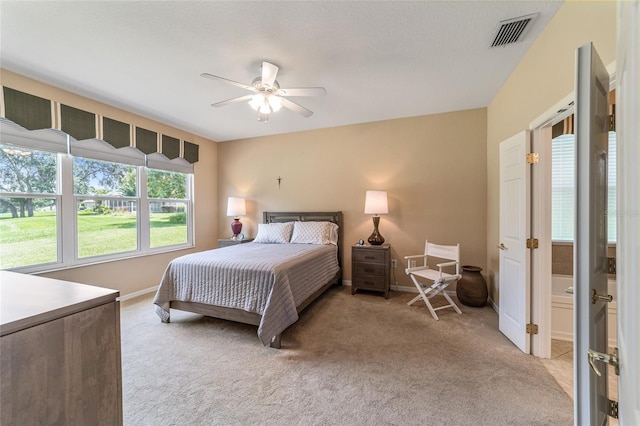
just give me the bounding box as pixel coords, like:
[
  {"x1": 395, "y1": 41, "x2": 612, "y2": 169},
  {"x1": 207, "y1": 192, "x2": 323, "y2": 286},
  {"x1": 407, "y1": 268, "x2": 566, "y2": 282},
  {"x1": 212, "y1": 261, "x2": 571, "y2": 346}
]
[{"x1": 218, "y1": 108, "x2": 487, "y2": 286}]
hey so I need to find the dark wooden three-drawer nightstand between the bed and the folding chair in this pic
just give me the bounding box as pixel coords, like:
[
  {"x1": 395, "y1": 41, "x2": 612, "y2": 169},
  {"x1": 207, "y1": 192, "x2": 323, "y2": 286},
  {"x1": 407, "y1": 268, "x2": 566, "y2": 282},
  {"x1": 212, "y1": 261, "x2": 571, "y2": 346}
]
[{"x1": 351, "y1": 244, "x2": 391, "y2": 299}]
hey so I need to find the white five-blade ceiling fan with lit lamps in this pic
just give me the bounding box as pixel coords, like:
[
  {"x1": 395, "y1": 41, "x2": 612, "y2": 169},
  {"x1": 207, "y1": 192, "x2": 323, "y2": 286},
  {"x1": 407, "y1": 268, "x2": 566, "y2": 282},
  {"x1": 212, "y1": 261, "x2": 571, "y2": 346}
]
[{"x1": 200, "y1": 61, "x2": 327, "y2": 123}]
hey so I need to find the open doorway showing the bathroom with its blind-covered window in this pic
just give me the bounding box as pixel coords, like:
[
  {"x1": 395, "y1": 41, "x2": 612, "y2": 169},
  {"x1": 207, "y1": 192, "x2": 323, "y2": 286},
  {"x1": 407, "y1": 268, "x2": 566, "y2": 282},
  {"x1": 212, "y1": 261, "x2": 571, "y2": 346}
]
[{"x1": 532, "y1": 90, "x2": 617, "y2": 350}]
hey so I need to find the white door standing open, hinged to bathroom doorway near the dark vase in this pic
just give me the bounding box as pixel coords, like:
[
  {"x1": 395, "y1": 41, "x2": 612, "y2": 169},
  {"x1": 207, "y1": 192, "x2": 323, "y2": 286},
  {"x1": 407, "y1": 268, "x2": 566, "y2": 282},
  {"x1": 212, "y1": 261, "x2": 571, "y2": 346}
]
[{"x1": 498, "y1": 131, "x2": 531, "y2": 354}]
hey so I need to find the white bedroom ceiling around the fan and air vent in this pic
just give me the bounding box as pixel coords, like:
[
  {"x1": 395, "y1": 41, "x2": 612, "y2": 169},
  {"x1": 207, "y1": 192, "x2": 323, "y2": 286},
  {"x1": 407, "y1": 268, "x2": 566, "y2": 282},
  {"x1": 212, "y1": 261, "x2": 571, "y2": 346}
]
[{"x1": 0, "y1": 0, "x2": 562, "y2": 142}]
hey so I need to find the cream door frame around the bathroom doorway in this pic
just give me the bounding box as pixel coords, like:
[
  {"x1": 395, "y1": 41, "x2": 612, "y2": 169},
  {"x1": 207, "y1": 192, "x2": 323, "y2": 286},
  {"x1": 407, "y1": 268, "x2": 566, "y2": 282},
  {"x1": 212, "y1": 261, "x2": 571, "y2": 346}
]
[{"x1": 528, "y1": 61, "x2": 616, "y2": 358}]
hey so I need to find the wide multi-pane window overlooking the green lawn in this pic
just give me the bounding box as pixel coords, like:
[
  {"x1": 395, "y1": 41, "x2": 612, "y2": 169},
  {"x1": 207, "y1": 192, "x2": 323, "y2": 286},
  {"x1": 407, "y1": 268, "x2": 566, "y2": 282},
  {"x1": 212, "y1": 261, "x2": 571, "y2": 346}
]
[{"x1": 0, "y1": 141, "x2": 193, "y2": 271}]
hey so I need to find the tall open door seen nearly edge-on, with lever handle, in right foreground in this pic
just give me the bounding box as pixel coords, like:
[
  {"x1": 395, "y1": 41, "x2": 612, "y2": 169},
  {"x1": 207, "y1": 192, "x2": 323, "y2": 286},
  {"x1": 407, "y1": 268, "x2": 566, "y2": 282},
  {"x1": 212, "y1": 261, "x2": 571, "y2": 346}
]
[{"x1": 573, "y1": 43, "x2": 609, "y2": 425}]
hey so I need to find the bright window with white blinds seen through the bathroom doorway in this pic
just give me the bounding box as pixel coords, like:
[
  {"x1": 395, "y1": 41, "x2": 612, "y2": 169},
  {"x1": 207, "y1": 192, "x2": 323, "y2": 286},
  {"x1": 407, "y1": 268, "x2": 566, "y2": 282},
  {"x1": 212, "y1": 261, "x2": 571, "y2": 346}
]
[{"x1": 551, "y1": 132, "x2": 616, "y2": 244}]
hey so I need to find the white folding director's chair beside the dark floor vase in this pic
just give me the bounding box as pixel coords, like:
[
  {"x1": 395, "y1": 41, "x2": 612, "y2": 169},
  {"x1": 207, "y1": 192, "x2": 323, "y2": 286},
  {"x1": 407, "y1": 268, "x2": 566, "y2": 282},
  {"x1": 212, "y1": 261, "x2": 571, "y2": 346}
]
[{"x1": 404, "y1": 241, "x2": 462, "y2": 320}]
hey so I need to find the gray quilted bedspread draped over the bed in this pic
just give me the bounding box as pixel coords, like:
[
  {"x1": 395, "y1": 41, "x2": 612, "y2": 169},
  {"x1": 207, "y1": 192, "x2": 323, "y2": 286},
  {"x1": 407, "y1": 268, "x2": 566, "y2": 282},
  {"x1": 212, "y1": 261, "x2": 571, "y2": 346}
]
[{"x1": 153, "y1": 243, "x2": 339, "y2": 345}]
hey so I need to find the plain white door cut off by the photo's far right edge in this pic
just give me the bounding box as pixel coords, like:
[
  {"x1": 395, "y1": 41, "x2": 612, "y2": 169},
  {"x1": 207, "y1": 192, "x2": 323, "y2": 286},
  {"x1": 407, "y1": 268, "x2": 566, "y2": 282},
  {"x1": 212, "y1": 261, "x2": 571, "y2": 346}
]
[{"x1": 616, "y1": 1, "x2": 640, "y2": 425}]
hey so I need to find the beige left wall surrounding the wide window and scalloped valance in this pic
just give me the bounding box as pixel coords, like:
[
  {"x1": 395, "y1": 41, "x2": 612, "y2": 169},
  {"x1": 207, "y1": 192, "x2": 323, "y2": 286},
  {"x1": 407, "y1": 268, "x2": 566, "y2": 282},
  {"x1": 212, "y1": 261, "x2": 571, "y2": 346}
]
[{"x1": 0, "y1": 70, "x2": 218, "y2": 295}]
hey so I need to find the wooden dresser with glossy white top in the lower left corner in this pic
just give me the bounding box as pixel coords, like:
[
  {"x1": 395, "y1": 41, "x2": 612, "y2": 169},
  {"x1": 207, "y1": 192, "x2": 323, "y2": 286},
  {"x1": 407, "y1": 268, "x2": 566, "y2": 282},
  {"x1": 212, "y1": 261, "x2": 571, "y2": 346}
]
[{"x1": 0, "y1": 271, "x2": 122, "y2": 425}]
